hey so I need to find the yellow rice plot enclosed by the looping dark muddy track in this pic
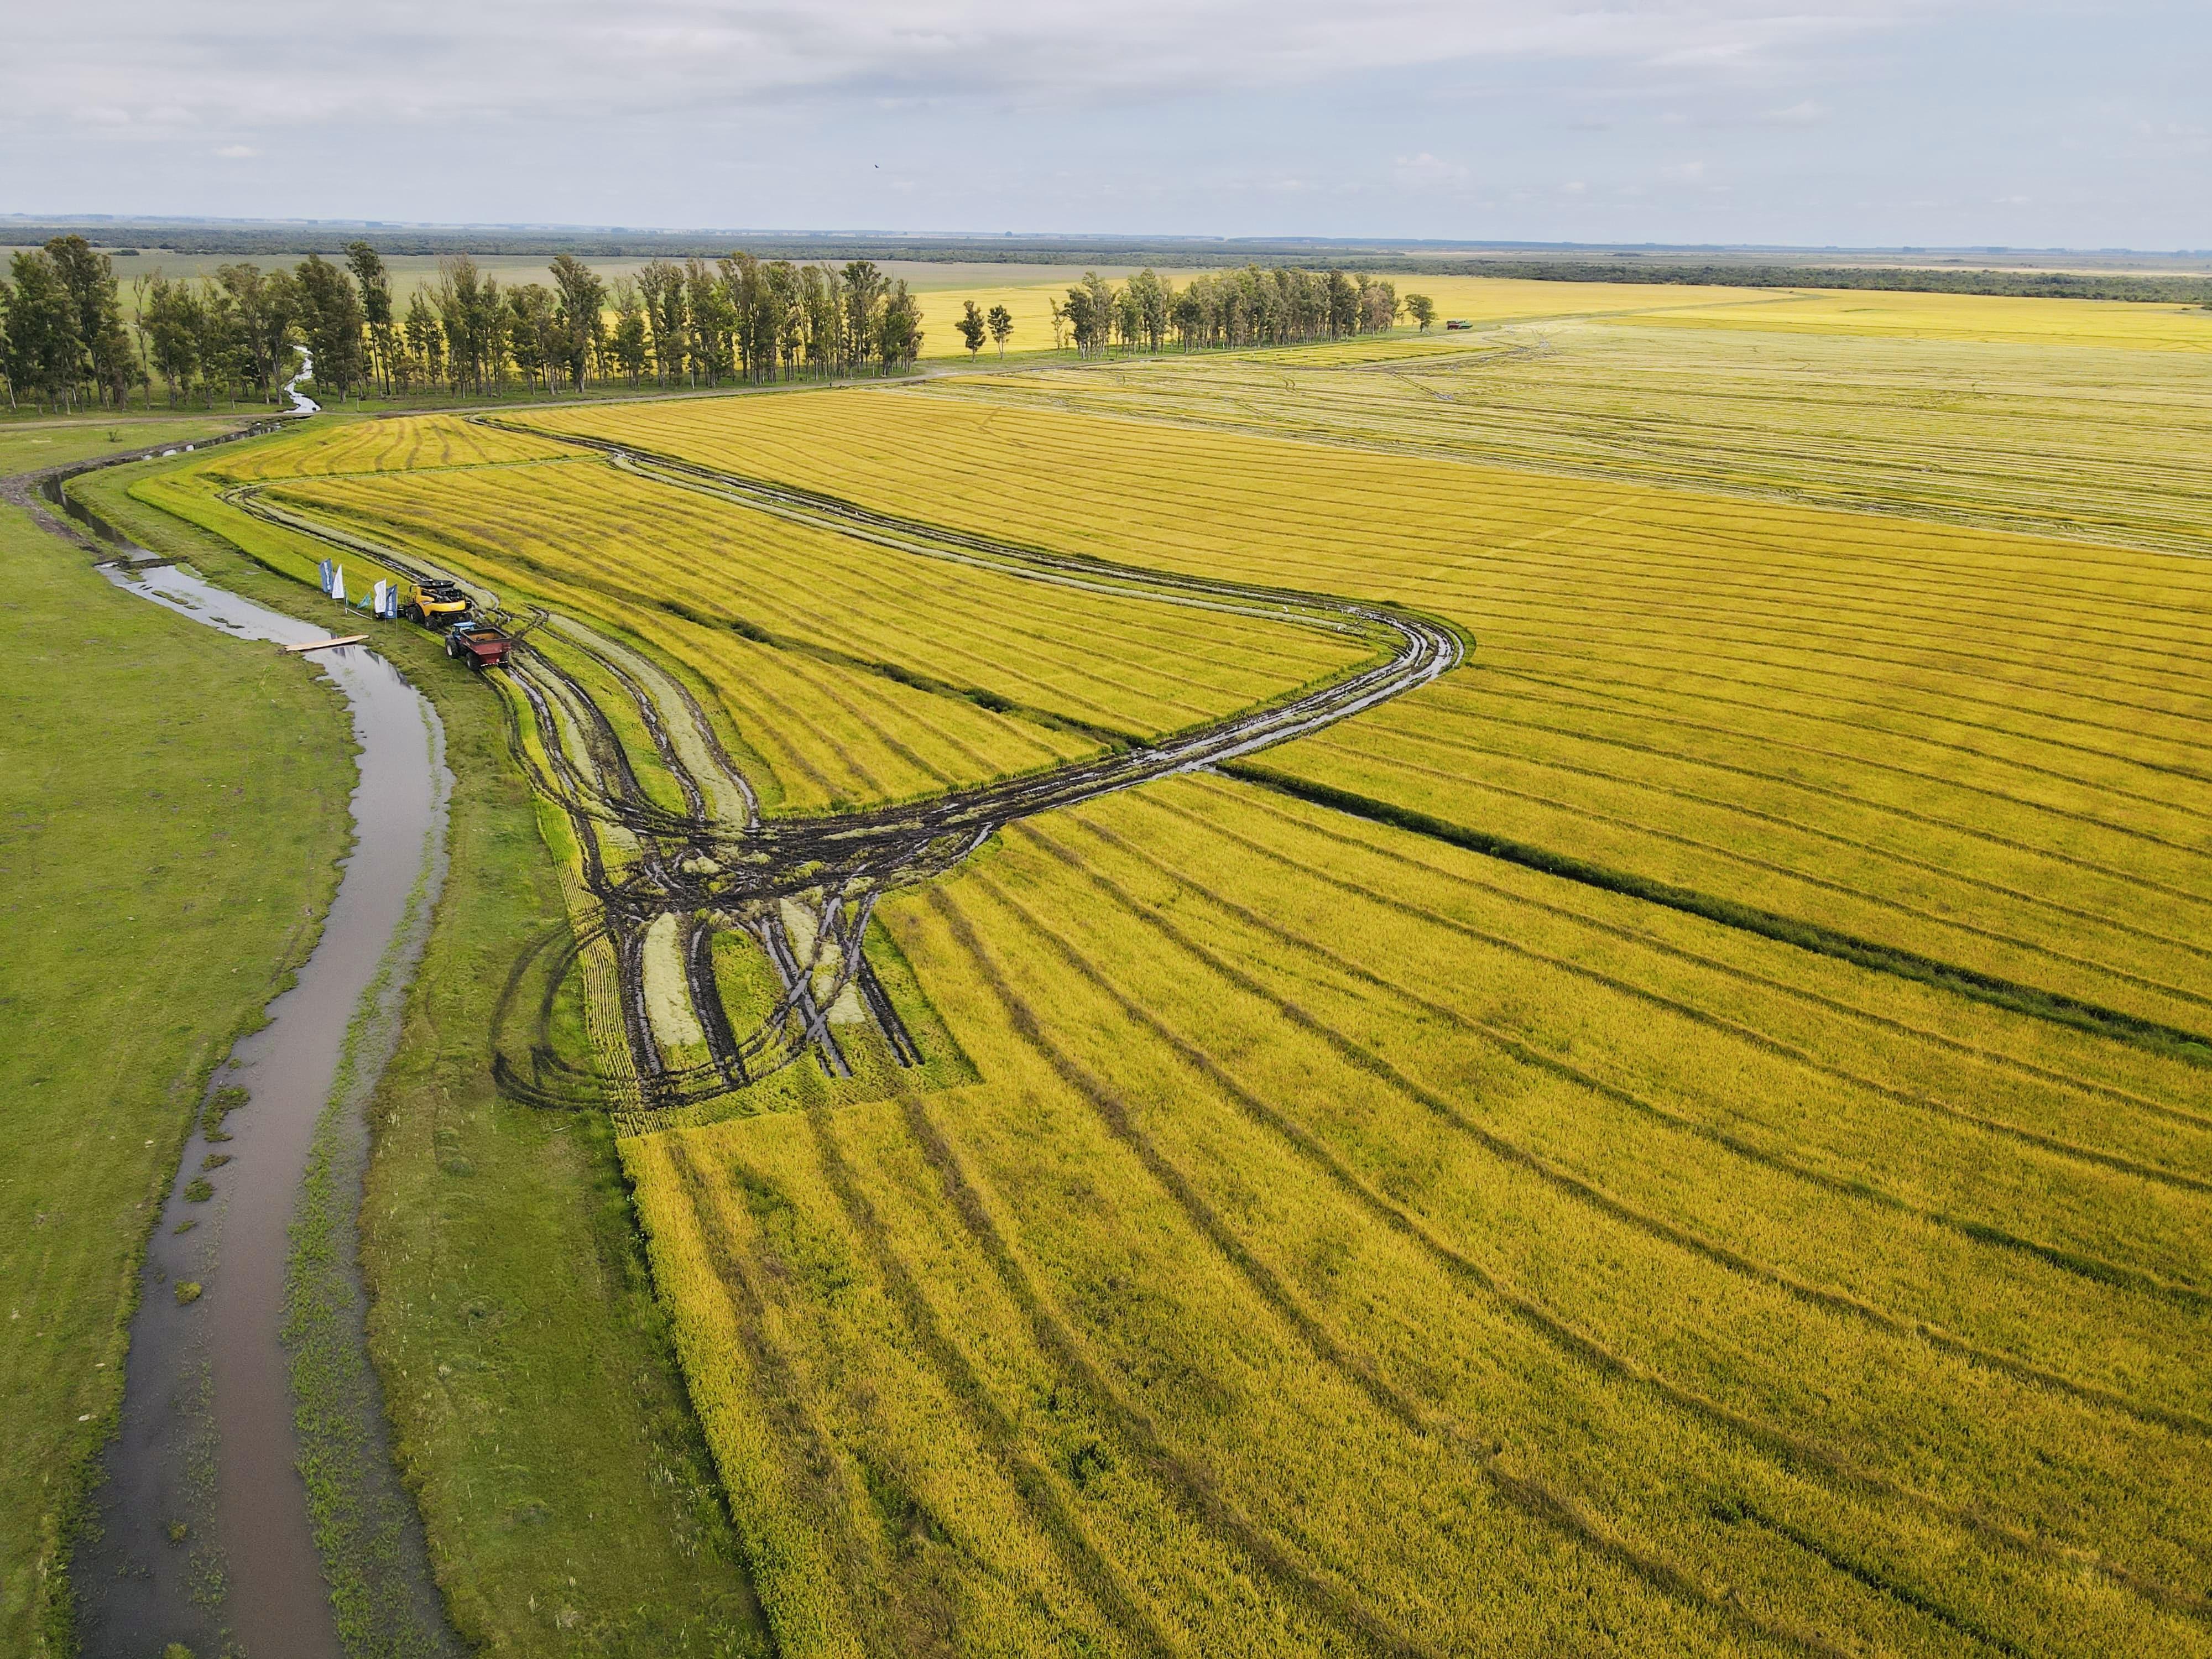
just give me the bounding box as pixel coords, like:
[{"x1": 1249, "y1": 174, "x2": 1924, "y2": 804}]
[{"x1": 199, "y1": 416, "x2": 1360, "y2": 810}]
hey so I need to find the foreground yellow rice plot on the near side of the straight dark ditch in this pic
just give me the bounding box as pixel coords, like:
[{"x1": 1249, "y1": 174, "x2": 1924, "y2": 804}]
[{"x1": 626, "y1": 783, "x2": 2212, "y2": 1652}]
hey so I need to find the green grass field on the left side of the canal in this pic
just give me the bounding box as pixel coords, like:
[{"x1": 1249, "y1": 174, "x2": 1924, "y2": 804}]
[{"x1": 0, "y1": 493, "x2": 354, "y2": 1652}]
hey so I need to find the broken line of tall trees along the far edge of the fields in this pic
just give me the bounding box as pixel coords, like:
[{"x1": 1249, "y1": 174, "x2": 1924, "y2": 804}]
[{"x1": 0, "y1": 237, "x2": 1436, "y2": 409}]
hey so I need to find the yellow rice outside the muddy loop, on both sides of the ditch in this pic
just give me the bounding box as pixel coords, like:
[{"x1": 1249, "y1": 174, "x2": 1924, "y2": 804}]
[{"x1": 522, "y1": 312, "x2": 2212, "y2": 1652}]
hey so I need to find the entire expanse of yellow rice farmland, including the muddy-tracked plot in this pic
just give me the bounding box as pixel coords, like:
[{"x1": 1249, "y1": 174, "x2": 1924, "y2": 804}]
[{"x1": 156, "y1": 285, "x2": 2212, "y2": 1655}]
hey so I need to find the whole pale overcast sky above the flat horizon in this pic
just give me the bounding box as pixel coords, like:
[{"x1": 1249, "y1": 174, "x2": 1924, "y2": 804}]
[{"x1": 0, "y1": 0, "x2": 2212, "y2": 248}]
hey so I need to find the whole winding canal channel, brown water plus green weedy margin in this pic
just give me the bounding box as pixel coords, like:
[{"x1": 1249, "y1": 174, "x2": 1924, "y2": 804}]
[{"x1": 55, "y1": 524, "x2": 458, "y2": 1659}]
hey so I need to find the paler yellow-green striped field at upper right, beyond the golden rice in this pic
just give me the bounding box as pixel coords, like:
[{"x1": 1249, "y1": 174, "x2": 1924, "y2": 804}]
[{"x1": 916, "y1": 296, "x2": 2212, "y2": 553}]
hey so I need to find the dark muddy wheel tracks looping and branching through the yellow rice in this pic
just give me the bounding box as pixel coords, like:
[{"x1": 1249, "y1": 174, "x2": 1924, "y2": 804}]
[{"x1": 232, "y1": 422, "x2": 1464, "y2": 1126}]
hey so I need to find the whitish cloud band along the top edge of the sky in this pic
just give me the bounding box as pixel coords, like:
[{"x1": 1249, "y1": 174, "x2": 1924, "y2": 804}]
[{"x1": 0, "y1": 0, "x2": 1980, "y2": 126}]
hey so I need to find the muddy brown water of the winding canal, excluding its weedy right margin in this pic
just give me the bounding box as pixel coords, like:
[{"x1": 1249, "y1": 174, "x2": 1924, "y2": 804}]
[{"x1": 71, "y1": 566, "x2": 445, "y2": 1659}]
